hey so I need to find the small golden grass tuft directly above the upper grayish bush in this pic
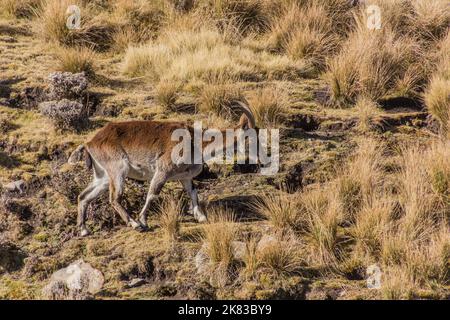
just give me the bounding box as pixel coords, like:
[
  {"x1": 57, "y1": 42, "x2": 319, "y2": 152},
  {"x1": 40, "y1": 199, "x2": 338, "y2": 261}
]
[{"x1": 56, "y1": 47, "x2": 97, "y2": 77}]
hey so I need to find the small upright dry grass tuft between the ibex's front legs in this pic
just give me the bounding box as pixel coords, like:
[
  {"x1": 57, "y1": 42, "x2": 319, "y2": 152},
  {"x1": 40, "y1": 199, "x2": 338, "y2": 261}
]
[{"x1": 158, "y1": 198, "x2": 183, "y2": 243}]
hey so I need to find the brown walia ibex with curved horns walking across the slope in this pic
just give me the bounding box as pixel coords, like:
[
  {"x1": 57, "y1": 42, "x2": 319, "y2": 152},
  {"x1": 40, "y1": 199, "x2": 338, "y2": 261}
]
[{"x1": 69, "y1": 102, "x2": 255, "y2": 236}]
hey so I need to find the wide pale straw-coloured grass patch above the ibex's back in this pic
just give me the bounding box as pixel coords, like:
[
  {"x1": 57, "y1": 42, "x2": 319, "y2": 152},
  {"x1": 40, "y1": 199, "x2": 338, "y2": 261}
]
[{"x1": 123, "y1": 27, "x2": 303, "y2": 82}]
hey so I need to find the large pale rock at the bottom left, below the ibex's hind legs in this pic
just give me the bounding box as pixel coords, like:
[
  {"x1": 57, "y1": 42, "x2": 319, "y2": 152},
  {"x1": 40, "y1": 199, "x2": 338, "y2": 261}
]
[{"x1": 42, "y1": 260, "x2": 104, "y2": 300}]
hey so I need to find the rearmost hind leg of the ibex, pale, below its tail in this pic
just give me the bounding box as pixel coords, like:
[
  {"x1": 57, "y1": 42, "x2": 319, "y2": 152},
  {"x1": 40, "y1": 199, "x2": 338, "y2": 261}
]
[{"x1": 77, "y1": 165, "x2": 109, "y2": 237}]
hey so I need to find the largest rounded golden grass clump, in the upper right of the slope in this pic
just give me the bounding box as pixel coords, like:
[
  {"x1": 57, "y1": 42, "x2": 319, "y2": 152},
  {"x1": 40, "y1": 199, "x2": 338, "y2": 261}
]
[{"x1": 325, "y1": 27, "x2": 427, "y2": 106}]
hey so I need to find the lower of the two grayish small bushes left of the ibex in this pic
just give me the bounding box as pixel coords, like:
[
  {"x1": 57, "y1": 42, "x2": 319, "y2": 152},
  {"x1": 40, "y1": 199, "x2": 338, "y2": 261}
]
[{"x1": 39, "y1": 99, "x2": 88, "y2": 130}]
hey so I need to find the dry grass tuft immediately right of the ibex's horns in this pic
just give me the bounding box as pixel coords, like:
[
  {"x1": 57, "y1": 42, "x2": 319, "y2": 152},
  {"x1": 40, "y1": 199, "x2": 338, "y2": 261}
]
[{"x1": 248, "y1": 87, "x2": 289, "y2": 128}]
